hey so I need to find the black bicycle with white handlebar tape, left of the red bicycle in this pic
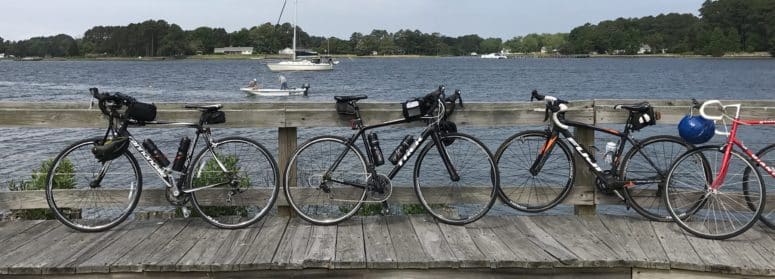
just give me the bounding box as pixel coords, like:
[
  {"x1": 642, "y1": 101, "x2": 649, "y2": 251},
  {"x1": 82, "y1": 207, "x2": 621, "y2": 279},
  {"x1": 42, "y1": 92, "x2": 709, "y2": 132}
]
[{"x1": 495, "y1": 90, "x2": 692, "y2": 221}]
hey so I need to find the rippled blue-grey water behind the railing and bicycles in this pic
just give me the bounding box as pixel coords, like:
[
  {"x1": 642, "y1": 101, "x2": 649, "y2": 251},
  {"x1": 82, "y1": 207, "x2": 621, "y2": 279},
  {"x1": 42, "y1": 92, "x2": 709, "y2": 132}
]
[{"x1": 0, "y1": 57, "x2": 775, "y2": 188}]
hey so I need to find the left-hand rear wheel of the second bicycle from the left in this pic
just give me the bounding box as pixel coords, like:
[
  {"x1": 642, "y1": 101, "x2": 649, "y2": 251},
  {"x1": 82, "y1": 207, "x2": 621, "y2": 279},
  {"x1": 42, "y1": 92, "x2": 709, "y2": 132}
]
[{"x1": 283, "y1": 136, "x2": 368, "y2": 225}]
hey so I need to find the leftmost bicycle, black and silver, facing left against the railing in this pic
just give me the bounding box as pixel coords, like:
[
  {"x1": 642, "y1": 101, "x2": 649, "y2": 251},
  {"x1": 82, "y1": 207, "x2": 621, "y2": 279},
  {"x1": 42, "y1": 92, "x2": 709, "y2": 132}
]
[{"x1": 46, "y1": 88, "x2": 279, "y2": 232}]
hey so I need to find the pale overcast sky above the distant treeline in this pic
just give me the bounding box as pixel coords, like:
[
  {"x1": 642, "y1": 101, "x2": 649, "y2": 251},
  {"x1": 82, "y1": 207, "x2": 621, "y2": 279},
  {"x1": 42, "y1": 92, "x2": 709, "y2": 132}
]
[{"x1": 0, "y1": 0, "x2": 703, "y2": 40}]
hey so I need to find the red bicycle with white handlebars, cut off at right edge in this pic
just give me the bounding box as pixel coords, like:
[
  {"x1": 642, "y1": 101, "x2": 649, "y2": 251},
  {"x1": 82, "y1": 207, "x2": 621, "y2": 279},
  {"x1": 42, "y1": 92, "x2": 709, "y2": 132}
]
[{"x1": 664, "y1": 100, "x2": 775, "y2": 239}]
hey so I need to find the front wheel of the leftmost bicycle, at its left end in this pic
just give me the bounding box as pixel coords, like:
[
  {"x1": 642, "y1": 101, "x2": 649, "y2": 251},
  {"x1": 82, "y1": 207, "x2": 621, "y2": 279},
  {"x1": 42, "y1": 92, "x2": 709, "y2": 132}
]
[{"x1": 45, "y1": 139, "x2": 143, "y2": 232}]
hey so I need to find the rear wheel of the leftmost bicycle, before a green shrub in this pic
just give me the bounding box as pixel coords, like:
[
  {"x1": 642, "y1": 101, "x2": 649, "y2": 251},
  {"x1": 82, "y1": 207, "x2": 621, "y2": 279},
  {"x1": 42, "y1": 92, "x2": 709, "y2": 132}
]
[{"x1": 185, "y1": 137, "x2": 279, "y2": 229}]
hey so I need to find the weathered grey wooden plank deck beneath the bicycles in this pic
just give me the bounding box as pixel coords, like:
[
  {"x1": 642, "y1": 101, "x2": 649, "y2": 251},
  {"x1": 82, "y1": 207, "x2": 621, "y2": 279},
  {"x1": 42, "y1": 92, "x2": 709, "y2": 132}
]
[{"x1": 0, "y1": 215, "x2": 775, "y2": 277}]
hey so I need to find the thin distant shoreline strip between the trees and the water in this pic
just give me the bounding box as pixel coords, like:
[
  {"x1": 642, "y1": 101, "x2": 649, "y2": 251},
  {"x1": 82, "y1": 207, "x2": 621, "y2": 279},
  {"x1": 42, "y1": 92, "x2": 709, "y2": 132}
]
[{"x1": 9, "y1": 52, "x2": 775, "y2": 61}]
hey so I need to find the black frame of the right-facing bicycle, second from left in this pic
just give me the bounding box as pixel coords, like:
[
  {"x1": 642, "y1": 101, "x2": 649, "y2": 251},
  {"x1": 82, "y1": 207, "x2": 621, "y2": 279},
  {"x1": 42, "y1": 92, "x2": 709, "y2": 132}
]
[{"x1": 323, "y1": 102, "x2": 460, "y2": 196}]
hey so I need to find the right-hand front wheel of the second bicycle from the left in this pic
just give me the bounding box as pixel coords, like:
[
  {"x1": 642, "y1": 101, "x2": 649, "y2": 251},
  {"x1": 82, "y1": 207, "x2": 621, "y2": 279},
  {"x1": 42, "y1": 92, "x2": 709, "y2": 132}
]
[{"x1": 414, "y1": 133, "x2": 500, "y2": 225}]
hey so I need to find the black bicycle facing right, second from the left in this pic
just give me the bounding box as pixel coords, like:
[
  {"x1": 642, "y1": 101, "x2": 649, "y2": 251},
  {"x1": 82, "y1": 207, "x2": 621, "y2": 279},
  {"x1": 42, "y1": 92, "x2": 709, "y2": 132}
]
[{"x1": 283, "y1": 87, "x2": 499, "y2": 225}]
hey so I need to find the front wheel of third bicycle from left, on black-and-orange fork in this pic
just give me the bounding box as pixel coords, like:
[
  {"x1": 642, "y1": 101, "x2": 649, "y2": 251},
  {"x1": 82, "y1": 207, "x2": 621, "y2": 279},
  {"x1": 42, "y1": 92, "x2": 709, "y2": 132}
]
[{"x1": 495, "y1": 130, "x2": 576, "y2": 213}]
